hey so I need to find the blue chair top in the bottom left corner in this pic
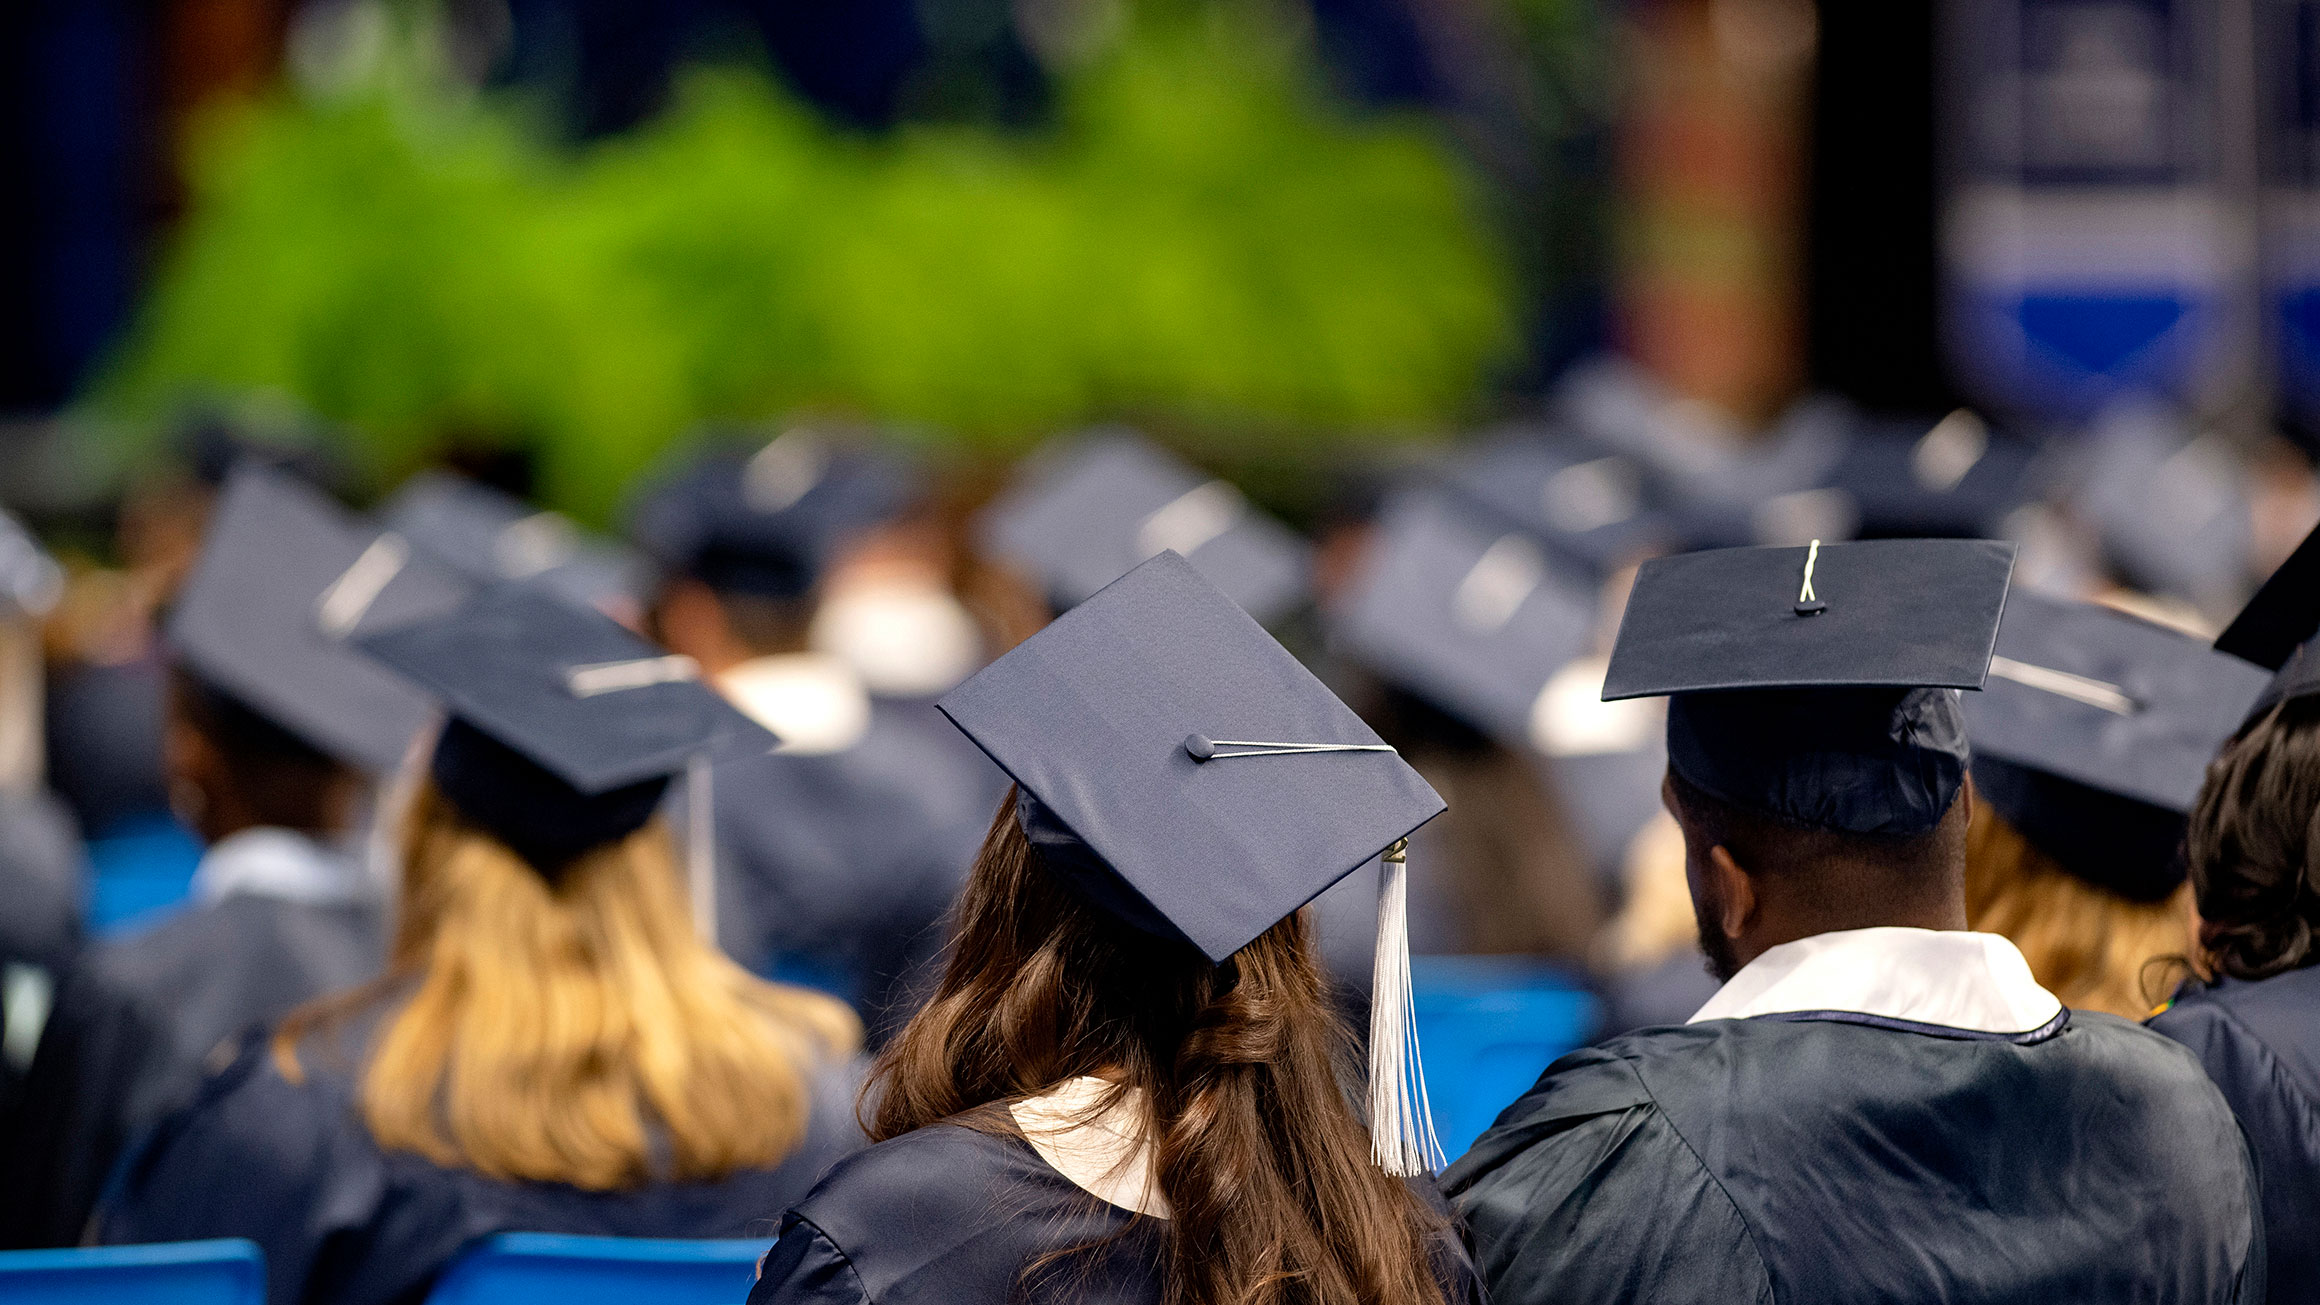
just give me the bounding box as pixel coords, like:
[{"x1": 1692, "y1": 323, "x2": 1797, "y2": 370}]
[{"x1": 0, "y1": 1238, "x2": 267, "y2": 1305}]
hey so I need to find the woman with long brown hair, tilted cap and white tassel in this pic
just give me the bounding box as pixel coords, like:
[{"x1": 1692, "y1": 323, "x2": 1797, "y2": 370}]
[{"x1": 749, "y1": 553, "x2": 1476, "y2": 1305}]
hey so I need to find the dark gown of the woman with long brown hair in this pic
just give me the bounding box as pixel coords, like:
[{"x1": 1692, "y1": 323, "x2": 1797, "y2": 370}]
[{"x1": 749, "y1": 1124, "x2": 1480, "y2": 1305}]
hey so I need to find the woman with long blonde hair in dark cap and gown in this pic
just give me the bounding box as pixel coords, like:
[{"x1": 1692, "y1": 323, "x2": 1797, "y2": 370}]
[{"x1": 100, "y1": 585, "x2": 861, "y2": 1305}]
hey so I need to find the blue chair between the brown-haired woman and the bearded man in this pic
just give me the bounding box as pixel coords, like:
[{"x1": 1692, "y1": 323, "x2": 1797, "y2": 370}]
[{"x1": 1411, "y1": 957, "x2": 1601, "y2": 1159}]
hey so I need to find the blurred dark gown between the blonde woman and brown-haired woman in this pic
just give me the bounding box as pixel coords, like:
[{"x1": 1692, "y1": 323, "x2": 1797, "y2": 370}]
[{"x1": 712, "y1": 706, "x2": 991, "y2": 1043}]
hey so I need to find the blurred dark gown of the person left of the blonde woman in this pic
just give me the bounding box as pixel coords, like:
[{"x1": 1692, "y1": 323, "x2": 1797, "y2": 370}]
[{"x1": 0, "y1": 892, "x2": 387, "y2": 1247}]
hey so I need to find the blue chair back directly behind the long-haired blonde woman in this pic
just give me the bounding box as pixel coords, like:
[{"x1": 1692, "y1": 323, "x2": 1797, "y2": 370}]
[{"x1": 427, "y1": 1233, "x2": 773, "y2": 1305}]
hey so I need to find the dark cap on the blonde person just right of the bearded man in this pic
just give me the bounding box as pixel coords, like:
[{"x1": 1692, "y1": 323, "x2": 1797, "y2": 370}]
[{"x1": 1965, "y1": 594, "x2": 2264, "y2": 887}]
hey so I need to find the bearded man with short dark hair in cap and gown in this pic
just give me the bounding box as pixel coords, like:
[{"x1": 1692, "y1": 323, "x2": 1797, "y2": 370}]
[{"x1": 1443, "y1": 541, "x2": 2264, "y2": 1305}]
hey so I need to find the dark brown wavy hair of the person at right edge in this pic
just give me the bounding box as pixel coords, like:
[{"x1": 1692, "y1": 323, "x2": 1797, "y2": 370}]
[{"x1": 2183, "y1": 697, "x2": 2320, "y2": 980}]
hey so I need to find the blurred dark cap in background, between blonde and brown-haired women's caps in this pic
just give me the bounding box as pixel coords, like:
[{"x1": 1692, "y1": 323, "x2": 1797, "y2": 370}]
[{"x1": 629, "y1": 427, "x2": 921, "y2": 599}]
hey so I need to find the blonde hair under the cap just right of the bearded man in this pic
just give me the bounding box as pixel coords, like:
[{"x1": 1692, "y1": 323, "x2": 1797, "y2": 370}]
[{"x1": 1965, "y1": 801, "x2": 2190, "y2": 1019}]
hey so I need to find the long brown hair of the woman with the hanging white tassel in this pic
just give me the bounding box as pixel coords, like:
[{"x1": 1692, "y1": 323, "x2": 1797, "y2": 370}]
[{"x1": 868, "y1": 796, "x2": 1445, "y2": 1305}]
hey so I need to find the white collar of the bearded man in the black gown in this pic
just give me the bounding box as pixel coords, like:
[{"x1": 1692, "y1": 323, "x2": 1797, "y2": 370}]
[{"x1": 1691, "y1": 929, "x2": 2062, "y2": 1033}]
